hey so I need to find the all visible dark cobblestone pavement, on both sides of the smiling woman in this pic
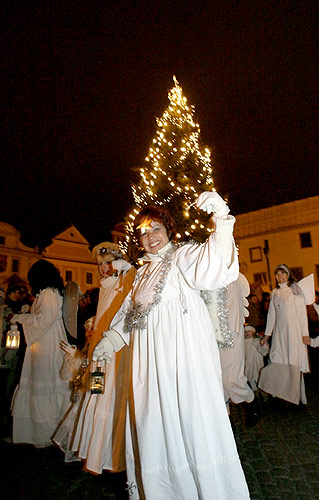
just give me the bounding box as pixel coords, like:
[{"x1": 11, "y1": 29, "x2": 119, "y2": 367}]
[{"x1": 1, "y1": 371, "x2": 319, "y2": 500}]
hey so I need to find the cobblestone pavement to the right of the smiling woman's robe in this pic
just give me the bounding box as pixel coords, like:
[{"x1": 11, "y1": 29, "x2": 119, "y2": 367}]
[{"x1": 232, "y1": 374, "x2": 319, "y2": 500}]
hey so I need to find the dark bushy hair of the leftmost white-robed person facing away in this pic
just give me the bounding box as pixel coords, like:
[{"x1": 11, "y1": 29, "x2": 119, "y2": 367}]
[{"x1": 28, "y1": 259, "x2": 64, "y2": 296}]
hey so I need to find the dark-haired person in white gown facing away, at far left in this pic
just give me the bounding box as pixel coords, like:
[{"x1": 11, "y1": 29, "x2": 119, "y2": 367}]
[{"x1": 11, "y1": 260, "x2": 71, "y2": 447}]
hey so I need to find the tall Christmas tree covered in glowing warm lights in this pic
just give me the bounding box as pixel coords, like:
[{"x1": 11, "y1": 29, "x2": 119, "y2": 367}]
[{"x1": 127, "y1": 77, "x2": 213, "y2": 254}]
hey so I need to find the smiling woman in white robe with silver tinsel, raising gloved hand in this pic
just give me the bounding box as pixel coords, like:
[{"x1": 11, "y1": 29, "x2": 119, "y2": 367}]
[{"x1": 93, "y1": 192, "x2": 249, "y2": 500}]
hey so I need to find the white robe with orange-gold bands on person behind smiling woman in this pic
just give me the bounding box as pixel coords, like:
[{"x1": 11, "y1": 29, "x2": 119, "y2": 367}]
[{"x1": 71, "y1": 263, "x2": 135, "y2": 474}]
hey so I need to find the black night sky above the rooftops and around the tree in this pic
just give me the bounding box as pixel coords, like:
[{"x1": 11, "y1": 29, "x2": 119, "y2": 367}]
[{"x1": 0, "y1": 0, "x2": 319, "y2": 246}]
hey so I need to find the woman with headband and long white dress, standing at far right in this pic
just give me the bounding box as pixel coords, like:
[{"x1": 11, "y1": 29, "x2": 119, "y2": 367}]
[{"x1": 258, "y1": 264, "x2": 309, "y2": 404}]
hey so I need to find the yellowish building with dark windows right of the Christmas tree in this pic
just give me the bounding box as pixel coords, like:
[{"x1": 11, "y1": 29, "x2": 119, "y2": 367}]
[{"x1": 235, "y1": 196, "x2": 319, "y2": 289}]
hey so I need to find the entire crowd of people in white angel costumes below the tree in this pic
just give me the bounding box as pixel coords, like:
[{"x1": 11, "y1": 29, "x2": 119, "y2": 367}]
[{"x1": 1, "y1": 192, "x2": 319, "y2": 500}]
